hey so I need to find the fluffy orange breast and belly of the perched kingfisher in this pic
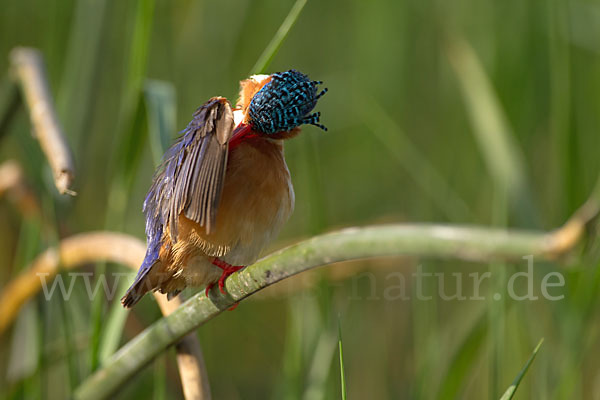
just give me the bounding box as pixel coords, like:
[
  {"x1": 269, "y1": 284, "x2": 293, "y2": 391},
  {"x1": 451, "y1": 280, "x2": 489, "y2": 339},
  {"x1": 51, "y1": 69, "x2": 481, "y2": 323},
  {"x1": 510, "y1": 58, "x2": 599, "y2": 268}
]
[{"x1": 167, "y1": 137, "x2": 294, "y2": 274}]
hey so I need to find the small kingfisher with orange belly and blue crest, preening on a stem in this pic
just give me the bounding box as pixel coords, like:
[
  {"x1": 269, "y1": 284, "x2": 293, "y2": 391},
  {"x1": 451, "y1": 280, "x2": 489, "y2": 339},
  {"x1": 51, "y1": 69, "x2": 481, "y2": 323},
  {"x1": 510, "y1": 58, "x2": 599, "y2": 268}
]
[{"x1": 121, "y1": 70, "x2": 327, "y2": 307}]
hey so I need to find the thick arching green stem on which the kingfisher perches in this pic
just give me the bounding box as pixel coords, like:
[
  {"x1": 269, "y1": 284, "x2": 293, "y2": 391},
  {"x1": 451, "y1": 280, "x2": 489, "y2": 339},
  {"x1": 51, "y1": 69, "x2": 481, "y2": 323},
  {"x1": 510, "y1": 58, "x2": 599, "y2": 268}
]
[{"x1": 75, "y1": 225, "x2": 568, "y2": 399}]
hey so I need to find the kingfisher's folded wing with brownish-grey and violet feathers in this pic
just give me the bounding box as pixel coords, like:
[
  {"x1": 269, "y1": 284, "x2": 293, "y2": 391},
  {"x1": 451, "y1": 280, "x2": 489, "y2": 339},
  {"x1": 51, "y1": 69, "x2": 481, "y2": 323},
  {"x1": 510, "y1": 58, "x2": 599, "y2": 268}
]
[{"x1": 144, "y1": 97, "x2": 234, "y2": 243}]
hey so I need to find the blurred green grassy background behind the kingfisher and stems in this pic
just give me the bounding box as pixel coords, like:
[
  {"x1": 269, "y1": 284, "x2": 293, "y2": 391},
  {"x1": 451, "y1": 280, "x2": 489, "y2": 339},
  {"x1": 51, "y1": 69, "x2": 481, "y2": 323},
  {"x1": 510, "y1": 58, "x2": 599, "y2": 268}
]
[{"x1": 0, "y1": 0, "x2": 600, "y2": 399}]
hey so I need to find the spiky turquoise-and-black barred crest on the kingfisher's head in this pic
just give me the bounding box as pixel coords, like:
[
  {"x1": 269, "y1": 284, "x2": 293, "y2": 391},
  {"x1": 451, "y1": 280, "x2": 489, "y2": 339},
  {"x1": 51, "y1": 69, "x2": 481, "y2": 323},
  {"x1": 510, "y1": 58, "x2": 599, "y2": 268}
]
[{"x1": 248, "y1": 69, "x2": 327, "y2": 134}]
